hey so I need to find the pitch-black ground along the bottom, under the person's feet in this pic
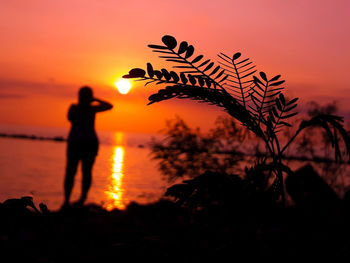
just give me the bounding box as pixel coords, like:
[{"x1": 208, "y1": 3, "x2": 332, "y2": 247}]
[{"x1": 0, "y1": 166, "x2": 350, "y2": 262}]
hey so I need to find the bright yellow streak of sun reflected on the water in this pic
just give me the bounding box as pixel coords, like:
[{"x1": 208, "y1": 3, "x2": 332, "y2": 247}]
[{"x1": 105, "y1": 146, "x2": 125, "y2": 210}]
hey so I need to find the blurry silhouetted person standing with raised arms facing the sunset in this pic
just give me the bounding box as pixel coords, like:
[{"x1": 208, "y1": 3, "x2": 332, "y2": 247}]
[{"x1": 63, "y1": 87, "x2": 113, "y2": 207}]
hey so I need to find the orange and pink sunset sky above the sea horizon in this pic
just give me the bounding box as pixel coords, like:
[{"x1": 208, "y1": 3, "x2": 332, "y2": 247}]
[{"x1": 0, "y1": 0, "x2": 350, "y2": 132}]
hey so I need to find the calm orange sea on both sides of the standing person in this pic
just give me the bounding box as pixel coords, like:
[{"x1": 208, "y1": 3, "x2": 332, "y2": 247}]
[{"x1": 0, "y1": 125, "x2": 167, "y2": 210}]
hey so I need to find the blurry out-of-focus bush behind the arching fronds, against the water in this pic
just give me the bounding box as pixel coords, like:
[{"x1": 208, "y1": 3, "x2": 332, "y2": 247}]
[{"x1": 151, "y1": 117, "x2": 249, "y2": 182}]
